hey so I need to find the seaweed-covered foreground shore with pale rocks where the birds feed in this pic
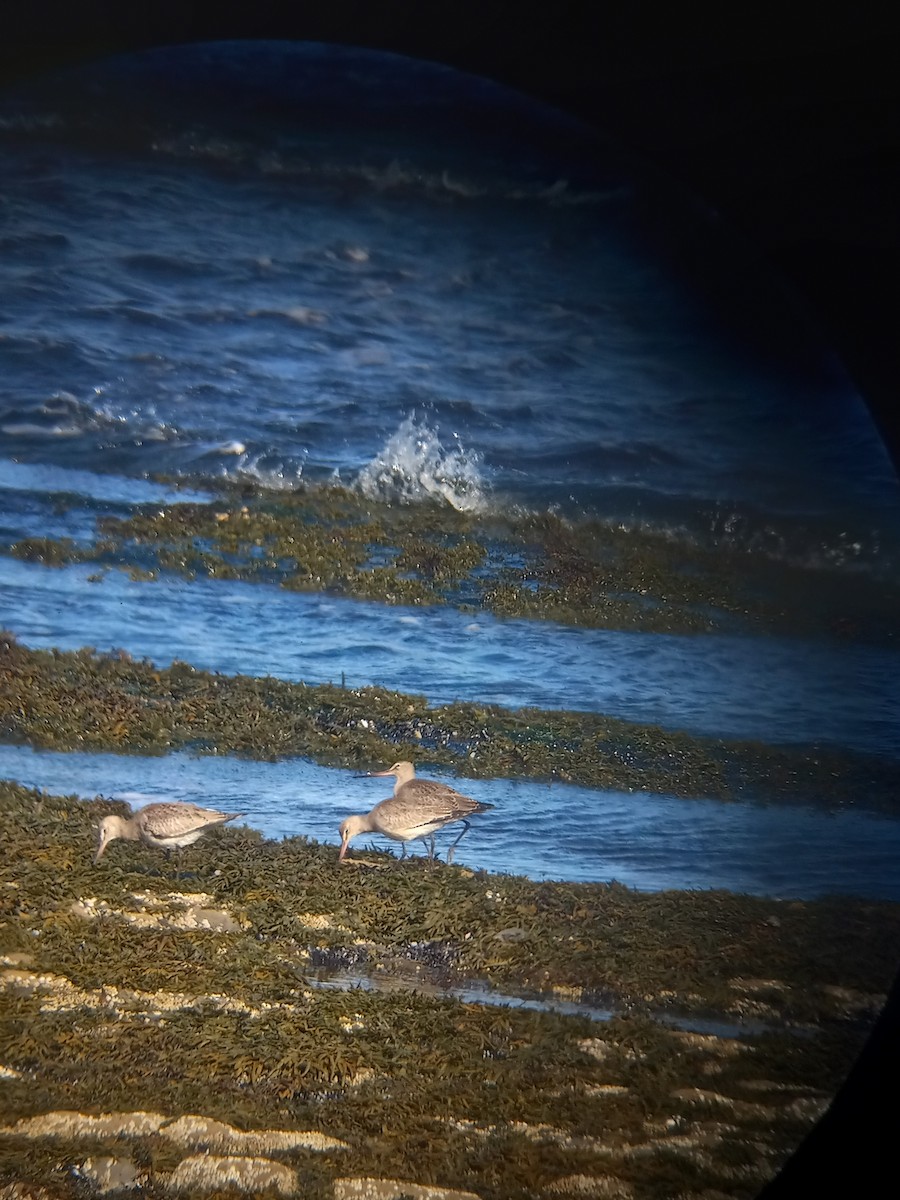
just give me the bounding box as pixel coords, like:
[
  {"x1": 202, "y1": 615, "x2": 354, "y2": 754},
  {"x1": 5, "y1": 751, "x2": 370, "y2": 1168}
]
[{"x1": 7, "y1": 782, "x2": 900, "y2": 1200}]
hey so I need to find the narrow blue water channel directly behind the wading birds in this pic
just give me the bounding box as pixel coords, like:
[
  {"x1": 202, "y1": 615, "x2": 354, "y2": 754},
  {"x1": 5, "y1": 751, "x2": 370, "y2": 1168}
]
[{"x1": 0, "y1": 745, "x2": 900, "y2": 900}]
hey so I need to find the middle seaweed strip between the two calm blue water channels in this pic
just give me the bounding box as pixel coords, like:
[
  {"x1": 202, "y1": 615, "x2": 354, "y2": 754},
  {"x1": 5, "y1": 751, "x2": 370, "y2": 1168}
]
[{"x1": 0, "y1": 632, "x2": 900, "y2": 815}]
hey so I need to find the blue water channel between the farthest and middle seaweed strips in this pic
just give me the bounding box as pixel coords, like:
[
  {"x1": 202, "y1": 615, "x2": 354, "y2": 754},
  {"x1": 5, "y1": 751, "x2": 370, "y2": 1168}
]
[{"x1": 0, "y1": 560, "x2": 900, "y2": 755}]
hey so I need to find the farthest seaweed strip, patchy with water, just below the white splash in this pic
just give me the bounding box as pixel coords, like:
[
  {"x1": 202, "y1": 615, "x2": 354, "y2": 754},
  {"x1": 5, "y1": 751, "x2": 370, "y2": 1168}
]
[{"x1": 0, "y1": 480, "x2": 900, "y2": 643}]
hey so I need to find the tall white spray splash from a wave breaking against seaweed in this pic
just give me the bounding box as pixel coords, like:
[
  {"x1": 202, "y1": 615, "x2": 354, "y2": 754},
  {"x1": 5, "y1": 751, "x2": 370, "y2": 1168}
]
[{"x1": 356, "y1": 413, "x2": 487, "y2": 512}]
